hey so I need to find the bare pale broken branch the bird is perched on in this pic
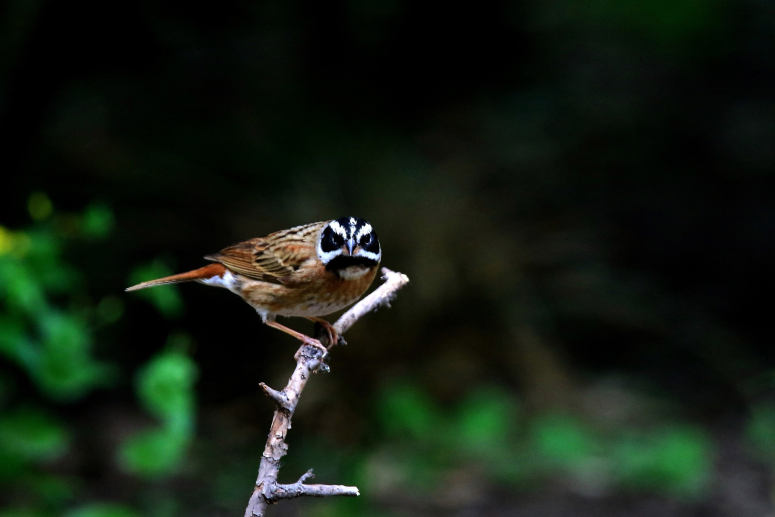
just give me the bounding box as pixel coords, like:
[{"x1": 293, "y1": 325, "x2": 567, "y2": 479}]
[{"x1": 245, "y1": 267, "x2": 409, "y2": 517}]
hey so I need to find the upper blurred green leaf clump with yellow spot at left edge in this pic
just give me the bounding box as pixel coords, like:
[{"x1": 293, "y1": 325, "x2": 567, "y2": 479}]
[{"x1": 0, "y1": 193, "x2": 111, "y2": 400}]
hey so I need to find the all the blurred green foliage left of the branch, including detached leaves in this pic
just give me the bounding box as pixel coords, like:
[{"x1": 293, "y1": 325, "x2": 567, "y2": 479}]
[{"x1": 0, "y1": 196, "x2": 196, "y2": 517}]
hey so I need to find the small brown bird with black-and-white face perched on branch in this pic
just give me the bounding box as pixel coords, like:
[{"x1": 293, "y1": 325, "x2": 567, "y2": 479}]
[{"x1": 126, "y1": 217, "x2": 382, "y2": 352}]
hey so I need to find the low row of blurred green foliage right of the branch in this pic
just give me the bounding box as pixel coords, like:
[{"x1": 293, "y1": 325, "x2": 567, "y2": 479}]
[{"x1": 366, "y1": 383, "x2": 715, "y2": 504}]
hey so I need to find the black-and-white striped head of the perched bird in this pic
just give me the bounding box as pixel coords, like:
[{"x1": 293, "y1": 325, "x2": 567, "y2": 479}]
[{"x1": 317, "y1": 217, "x2": 382, "y2": 265}]
